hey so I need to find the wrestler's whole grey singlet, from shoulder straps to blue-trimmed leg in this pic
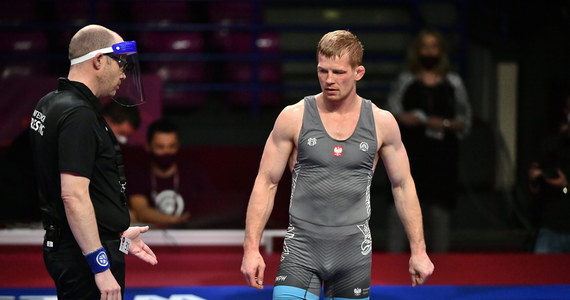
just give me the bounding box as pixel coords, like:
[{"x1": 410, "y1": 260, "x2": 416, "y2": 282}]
[{"x1": 273, "y1": 96, "x2": 377, "y2": 300}]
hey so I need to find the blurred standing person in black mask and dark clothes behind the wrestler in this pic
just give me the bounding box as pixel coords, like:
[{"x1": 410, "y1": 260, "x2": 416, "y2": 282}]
[{"x1": 388, "y1": 30, "x2": 471, "y2": 252}]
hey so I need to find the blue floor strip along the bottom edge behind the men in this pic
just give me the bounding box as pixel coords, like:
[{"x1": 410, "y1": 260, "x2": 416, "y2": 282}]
[{"x1": 0, "y1": 285, "x2": 570, "y2": 300}]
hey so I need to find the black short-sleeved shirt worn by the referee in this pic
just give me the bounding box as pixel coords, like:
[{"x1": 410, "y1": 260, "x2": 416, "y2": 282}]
[{"x1": 31, "y1": 78, "x2": 130, "y2": 236}]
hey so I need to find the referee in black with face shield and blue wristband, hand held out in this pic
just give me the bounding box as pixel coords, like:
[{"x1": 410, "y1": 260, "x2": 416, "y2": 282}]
[{"x1": 31, "y1": 25, "x2": 157, "y2": 300}]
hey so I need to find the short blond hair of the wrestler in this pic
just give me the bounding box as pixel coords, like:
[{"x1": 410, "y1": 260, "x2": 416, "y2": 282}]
[{"x1": 317, "y1": 30, "x2": 364, "y2": 69}]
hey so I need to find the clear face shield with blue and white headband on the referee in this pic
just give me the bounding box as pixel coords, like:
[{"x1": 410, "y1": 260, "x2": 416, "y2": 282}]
[{"x1": 71, "y1": 41, "x2": 145, "y2": 107}]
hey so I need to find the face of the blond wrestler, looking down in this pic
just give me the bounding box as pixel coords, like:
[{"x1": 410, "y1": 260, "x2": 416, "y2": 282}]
[{"x1": 317, "y1": 54, "x2": 364, "y2": 101}]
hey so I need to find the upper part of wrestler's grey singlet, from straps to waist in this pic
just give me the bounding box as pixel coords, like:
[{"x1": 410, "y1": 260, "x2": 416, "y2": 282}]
[{"x1": 289, "y1": 96, "x2": 377, "y2": 226}]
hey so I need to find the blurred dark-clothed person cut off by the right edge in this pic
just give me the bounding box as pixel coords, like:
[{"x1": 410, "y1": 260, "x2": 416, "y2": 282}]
[{"x1": 528, "y1": 96, "x2": 570, "y2": 254}]
